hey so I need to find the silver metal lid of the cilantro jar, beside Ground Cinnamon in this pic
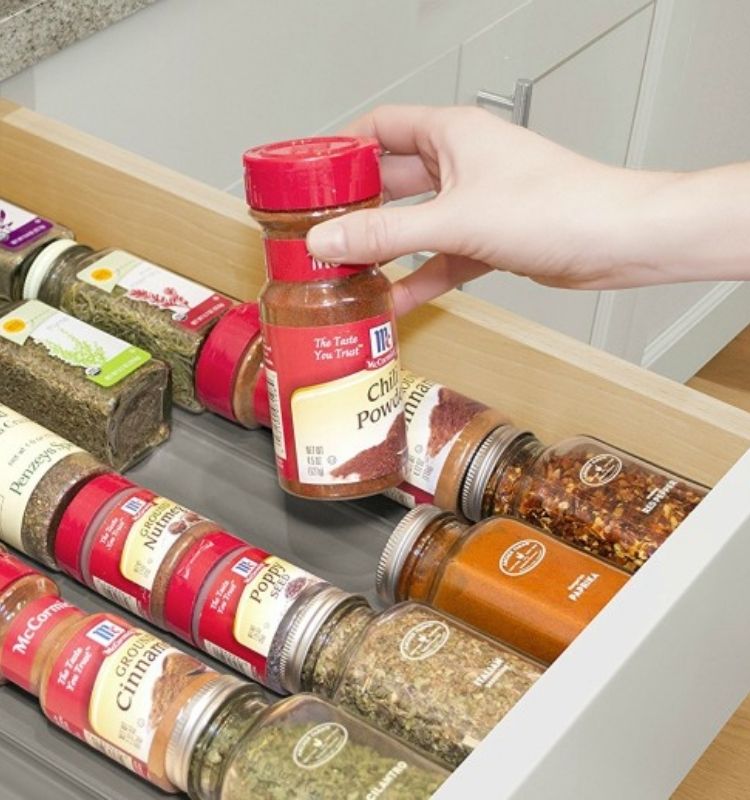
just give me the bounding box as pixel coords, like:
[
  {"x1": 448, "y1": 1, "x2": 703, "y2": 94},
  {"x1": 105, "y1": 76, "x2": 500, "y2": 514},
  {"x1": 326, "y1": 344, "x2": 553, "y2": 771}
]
[{"x1": 165, "y1": 675, "x2": 245, "y2": 792}]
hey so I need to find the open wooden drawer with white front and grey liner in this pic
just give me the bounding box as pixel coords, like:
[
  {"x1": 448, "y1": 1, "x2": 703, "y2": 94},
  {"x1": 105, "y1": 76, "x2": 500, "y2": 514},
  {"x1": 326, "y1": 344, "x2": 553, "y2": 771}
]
[{"x1": 0, "y1": 101, "x2": 750, "y2": 800}]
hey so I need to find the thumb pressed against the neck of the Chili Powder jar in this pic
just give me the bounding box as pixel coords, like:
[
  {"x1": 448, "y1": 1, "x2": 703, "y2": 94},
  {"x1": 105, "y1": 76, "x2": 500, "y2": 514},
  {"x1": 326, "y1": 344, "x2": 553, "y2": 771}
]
[{"x1": 307, "y1": 200, "x2": 449, "y2": 264}]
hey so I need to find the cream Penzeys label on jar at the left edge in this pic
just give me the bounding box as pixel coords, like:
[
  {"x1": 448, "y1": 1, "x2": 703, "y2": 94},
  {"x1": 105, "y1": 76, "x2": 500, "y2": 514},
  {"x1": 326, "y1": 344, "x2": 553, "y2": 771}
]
[{"x1": 0, "y1": 404, "x2": 83, "y2": 550}]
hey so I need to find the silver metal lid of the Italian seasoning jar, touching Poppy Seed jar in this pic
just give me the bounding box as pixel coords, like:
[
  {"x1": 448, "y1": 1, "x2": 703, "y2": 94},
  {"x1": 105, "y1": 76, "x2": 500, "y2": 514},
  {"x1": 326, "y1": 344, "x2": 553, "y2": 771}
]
[{"x1": 279, "y1": 586, "x2": 356, "y2": 694}]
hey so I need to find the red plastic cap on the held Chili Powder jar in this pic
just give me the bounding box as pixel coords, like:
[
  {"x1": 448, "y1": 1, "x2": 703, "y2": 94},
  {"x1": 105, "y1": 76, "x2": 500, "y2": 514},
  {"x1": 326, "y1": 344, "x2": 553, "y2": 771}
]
[{"x1": 243, "y1": 136, "x2": 383, "y2": 211}]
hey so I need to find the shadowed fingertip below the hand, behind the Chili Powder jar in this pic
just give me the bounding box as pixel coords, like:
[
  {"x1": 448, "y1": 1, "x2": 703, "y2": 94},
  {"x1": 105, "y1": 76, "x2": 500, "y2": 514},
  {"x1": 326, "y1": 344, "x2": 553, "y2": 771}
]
[{"x1": 393, "y1": 253, "x2": 492, "y2": 316}]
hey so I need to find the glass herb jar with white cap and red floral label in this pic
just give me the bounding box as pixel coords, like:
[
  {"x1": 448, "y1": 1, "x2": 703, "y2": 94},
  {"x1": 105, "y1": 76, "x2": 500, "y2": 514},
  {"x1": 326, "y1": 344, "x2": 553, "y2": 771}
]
[{"x1": 23, "y1": 240, "x2": 233, "y2": 411}]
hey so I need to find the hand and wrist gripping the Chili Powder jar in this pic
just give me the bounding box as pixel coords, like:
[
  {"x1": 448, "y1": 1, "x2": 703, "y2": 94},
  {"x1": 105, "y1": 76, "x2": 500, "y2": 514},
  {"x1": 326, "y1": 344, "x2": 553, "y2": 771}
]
[{"x1": 307, "y1": 106, "x2": 669, "y2": 313}]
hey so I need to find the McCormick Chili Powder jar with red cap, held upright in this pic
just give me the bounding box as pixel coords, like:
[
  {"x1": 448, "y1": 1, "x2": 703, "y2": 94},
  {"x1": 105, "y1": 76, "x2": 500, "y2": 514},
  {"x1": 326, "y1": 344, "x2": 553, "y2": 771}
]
[{"x1": 244, "y1": 137, "x2": 406, "y2": 499}]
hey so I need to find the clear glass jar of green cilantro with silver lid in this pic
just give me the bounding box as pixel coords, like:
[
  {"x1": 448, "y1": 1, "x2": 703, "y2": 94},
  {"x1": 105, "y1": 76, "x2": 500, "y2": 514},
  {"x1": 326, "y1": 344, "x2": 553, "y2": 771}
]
[{"x1": 167, "y1": 681, "x2": 448, "y2": 800}]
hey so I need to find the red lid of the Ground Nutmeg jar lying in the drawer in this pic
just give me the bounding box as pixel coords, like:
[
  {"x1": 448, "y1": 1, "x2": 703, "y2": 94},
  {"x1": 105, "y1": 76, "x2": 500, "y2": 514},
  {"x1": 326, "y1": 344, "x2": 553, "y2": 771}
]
[{"x1": 55, "y1": 472, "x2": 135, "y2": 581}]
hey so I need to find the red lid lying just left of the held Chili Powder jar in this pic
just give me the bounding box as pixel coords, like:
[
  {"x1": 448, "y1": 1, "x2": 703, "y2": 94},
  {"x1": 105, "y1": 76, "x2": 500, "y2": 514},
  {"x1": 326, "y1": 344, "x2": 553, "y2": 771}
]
[{"x1": 195, "y1": 303, "x2": 260, "y2": 422}]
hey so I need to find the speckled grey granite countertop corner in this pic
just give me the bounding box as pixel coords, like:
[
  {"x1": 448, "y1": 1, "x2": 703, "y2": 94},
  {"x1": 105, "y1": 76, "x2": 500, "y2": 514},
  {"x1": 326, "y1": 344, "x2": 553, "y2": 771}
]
[{"x1": 0, "y1": 0, "x2": 155, "y2": 81}]
